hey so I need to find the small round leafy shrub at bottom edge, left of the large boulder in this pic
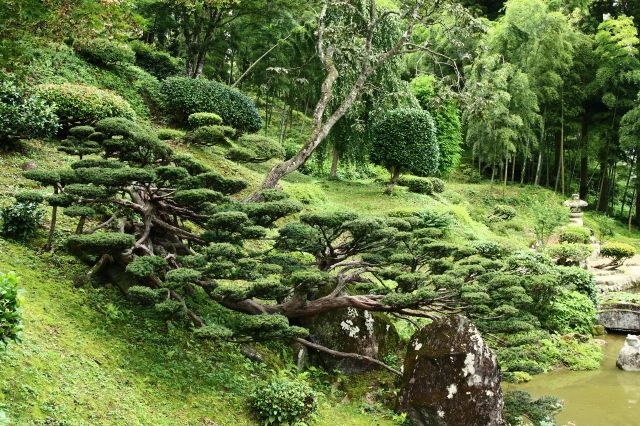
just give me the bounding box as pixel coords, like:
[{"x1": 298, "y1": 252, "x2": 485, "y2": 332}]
[{"x1": 251, "y1": 379, "x2": 317, "y2": 425}]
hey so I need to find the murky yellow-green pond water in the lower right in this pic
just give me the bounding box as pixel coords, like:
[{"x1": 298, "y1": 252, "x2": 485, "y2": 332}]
[{"x1": 505, "y1": 334, "x2": 640, "y2": 426}]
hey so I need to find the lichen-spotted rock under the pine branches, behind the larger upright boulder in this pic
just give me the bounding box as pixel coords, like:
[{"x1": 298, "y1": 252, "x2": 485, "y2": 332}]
[{"x1": 305, "y1": 308, "x2": 400, "y2": 374}]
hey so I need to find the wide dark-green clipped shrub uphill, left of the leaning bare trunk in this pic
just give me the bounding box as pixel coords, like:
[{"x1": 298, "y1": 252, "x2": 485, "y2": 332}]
[{"x1": 161, "y1": 77, "x2": 262, "y2": 133}]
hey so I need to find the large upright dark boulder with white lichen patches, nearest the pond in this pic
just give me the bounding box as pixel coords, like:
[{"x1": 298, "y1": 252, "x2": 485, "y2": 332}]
[{"x1": 397, "y1": 315, "x2": 504, "y2": 426}]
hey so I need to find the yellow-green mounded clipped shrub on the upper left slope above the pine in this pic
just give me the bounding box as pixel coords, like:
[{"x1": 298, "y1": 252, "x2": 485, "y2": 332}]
[{"x1": 36, "y1": 83, "x2": 136, "y2": 128}]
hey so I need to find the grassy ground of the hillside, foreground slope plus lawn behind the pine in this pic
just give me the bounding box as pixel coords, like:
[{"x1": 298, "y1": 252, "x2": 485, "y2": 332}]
[{"x1": 0, "y1": 142, "x2": 636, "y2": 425}]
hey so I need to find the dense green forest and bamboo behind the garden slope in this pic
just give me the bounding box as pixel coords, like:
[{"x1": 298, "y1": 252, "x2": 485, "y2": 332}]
[{"x1": 0, "y1": 0, "x2": 640, "y2": 222}]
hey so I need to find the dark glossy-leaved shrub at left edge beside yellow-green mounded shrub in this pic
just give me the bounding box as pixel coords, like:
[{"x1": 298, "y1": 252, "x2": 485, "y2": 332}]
[{"x1": 0, "y1": 77, "x2": 58, "y2": 149}]
